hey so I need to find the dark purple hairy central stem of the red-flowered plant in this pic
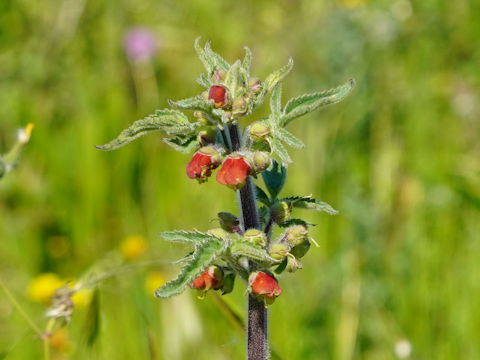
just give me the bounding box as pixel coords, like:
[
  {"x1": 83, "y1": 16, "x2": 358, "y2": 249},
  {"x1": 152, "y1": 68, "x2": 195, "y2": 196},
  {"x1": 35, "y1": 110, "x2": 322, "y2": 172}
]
[{"x1": 228, "y1": 125, "x2": 269, "y2": 360}]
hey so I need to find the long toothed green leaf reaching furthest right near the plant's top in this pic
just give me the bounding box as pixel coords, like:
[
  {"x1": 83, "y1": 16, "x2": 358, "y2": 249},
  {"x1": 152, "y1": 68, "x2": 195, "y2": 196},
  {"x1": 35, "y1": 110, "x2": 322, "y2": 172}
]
[{"x1": 281, "y1": 79, "x2": 355, "y2": 126}]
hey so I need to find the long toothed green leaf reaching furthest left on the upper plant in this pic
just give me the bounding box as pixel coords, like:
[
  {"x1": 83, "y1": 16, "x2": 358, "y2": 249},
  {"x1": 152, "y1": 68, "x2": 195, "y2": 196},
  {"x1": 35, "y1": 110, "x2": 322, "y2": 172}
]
[{"x1": 96, "y1": 109, "x2": 192, "y2": 151}]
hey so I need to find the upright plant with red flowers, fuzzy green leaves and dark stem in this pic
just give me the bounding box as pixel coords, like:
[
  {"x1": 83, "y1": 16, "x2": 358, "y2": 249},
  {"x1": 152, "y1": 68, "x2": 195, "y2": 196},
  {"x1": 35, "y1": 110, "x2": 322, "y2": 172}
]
[{"x1": 97, "y1": 38, "x2": 354, "y2": 359}]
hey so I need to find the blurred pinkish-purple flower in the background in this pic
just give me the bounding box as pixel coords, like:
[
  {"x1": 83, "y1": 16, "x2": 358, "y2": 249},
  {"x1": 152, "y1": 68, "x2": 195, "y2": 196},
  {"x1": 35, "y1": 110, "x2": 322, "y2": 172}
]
[{"x1": 125, "y1": 28, "x2": 157, "y2": 61}]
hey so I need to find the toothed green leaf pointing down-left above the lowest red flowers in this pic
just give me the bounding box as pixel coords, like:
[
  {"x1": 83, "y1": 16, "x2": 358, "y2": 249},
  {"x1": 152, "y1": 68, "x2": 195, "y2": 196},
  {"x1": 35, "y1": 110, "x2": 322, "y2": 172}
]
[{"x1": 155, "y1": 238, "x2": 229, "y2": 298}]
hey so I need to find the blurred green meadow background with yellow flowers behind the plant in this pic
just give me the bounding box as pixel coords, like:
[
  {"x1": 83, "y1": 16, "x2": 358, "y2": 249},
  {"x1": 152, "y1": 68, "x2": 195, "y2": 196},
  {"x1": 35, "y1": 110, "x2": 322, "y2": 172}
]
[{"x1": 0, "y1": 0, "x2": 480, "y2": 360}]
